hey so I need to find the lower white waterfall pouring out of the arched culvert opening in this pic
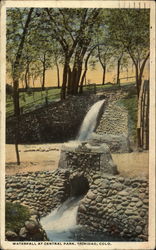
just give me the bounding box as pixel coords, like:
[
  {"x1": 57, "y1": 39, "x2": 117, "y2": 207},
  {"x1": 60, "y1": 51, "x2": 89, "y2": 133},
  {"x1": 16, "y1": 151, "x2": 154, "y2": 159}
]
[{"x1": 40, "y1": 197, "x2": 82, "y2": 241}]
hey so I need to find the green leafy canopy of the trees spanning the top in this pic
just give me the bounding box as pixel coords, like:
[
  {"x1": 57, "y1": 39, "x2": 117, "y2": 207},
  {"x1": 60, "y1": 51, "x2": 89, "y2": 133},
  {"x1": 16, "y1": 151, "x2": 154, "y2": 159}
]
[{"x1": 7, "y1": 8, "x2": 149, "y2": 96}]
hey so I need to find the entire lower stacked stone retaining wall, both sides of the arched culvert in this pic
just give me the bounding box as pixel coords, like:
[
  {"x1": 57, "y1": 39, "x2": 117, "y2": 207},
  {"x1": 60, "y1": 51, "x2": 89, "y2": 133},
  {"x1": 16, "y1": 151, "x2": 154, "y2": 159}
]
[{"x1": 6, "y1": 168, "x2": 148, "y2": 241}]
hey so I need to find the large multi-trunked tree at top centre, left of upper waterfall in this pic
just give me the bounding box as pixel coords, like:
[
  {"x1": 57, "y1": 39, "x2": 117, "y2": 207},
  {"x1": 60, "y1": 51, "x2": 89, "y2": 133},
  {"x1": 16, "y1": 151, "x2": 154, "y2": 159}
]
[{"x1": 46, "y1": 9, "x2": 101, "y2": 99}]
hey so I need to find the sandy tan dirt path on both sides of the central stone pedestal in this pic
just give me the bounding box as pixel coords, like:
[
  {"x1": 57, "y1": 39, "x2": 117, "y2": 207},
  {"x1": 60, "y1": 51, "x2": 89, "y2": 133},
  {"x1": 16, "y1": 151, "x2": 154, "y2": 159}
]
[{"x1": 6, "y1": 144, "x2": 149, "y2": 177}]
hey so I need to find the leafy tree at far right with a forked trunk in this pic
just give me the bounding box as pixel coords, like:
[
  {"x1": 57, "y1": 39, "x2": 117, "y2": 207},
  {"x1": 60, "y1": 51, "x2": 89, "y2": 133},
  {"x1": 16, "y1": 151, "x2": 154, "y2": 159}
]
[{"x1": 107, "y1": 9, "x2": 150, "y2": 97}]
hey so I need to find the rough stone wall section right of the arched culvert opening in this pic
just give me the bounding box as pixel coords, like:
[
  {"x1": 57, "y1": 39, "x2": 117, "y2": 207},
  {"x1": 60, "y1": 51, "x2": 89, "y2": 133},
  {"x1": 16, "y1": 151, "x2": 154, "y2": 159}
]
[{"x1": 77, "y1": 174, "x2": 148, "y2": 241}]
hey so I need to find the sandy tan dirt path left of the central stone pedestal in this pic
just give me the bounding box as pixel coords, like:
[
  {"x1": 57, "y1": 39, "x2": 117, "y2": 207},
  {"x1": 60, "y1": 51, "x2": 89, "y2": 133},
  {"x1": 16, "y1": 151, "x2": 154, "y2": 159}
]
[{"x1": 6, "y1": 144, "x2": 61, "y2": 175}]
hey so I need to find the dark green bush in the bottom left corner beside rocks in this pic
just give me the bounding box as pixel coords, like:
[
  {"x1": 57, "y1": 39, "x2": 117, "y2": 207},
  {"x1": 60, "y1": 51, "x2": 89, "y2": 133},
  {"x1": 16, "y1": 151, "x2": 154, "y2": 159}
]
[{"x1": 5, "y1": 202, "x2": 30, "y2": 233}]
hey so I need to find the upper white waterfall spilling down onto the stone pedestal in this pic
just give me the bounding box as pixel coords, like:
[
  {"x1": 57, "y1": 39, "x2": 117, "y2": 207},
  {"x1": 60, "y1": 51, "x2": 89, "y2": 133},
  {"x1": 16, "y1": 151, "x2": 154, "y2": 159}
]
[{"x1": 77, "y1": 100, "x2": 105, "y2": 141}]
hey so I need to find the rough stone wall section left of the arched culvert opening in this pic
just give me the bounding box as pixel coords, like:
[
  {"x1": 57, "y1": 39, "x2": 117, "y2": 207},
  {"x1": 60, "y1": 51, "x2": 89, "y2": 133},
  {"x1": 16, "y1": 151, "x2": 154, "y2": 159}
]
[{"x1": 6, "y1": 169, "x2": 69, "y2": 216}]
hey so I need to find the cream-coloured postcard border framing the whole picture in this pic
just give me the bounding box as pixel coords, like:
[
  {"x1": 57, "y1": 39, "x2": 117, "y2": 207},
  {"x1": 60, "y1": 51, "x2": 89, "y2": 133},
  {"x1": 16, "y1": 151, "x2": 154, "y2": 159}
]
[{"x1": 0, "y1": 1, "x2": 155, "y2": 250}]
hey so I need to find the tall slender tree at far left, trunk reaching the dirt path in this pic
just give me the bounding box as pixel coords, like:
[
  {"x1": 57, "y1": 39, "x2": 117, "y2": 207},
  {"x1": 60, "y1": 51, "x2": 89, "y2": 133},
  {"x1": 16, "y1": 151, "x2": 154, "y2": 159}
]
[{"x1": 7, "y1": 8, "x2": 33, "y2": 165}]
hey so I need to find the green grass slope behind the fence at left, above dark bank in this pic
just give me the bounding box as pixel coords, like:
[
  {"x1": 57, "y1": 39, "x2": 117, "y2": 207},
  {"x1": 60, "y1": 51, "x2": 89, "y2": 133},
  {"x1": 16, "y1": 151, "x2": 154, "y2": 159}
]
[{"x1": 6, "y1": 88, "x2": 60, "y2": 116}]
